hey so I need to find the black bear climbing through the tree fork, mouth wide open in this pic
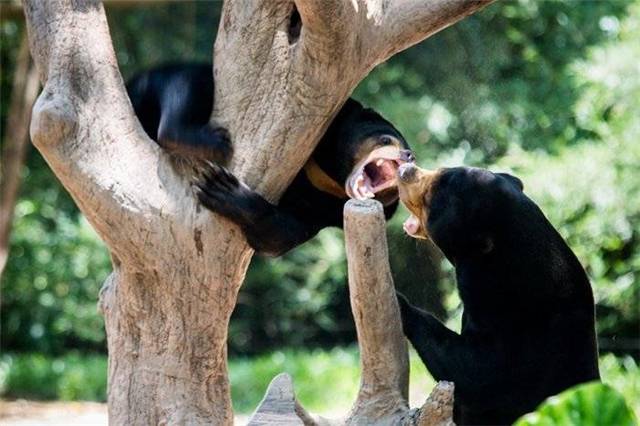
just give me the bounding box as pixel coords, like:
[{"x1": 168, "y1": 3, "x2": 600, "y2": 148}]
[{"x1": 127, "y1": 64, "x2": 413, "y2": 256}]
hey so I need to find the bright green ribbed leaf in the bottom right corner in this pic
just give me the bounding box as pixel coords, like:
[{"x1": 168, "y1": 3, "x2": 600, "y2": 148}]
[{"x1": 515, "y1": 382, "x2": 637, "y2": 426}]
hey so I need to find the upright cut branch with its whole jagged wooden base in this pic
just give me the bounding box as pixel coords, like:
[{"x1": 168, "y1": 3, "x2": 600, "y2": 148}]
[{"x1": 249, "y1": 200, "x2": 453, "y2": 426}]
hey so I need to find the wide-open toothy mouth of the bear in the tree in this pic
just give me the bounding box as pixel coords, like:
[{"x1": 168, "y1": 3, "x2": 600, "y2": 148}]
[{"x1": 345, "y1": 146, "x2": 406, "y2": 200}]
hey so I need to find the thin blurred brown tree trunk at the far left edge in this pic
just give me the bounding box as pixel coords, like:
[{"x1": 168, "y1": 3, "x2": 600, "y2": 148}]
[{"x1": 0, "y1": 33, "x2": 40, "y2": 277}]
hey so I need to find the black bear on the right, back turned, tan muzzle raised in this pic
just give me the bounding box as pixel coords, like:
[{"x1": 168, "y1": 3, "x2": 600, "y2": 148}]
[{"x1": 398, "y1": 164, "x2": 599, "y2": 424}]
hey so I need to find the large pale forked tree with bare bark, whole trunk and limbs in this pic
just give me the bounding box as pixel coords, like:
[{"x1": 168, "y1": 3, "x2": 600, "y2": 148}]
[{"x1": 20, "y1": 0, "x2": 488, "y2": 425}]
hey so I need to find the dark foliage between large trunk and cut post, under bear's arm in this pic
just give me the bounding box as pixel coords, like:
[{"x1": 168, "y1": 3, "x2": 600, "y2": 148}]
[{"x1": 229, "y1": 230, "x2": 354, "y2": 354}]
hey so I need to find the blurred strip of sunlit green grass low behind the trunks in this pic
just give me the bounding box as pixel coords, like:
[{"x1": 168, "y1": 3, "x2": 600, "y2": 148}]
[{"x1": 0, "y1": 346, "x2": 640, "y2": 425}]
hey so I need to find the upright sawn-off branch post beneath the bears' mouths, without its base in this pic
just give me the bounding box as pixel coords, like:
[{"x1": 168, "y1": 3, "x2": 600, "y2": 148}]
[{"x1": 344, "y1": 200, "x2": 409, "y2": 422}]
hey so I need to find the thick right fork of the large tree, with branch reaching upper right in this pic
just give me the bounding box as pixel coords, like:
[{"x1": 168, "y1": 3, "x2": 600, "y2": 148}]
[{"x1": 213, "y1": 0, "x2": 491, "y2": 201}]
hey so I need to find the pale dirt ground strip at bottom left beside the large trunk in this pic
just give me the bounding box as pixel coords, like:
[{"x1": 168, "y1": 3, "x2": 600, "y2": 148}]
[{"x1": 0, "y1": 400, "x2": 248, "y2": 426}]
